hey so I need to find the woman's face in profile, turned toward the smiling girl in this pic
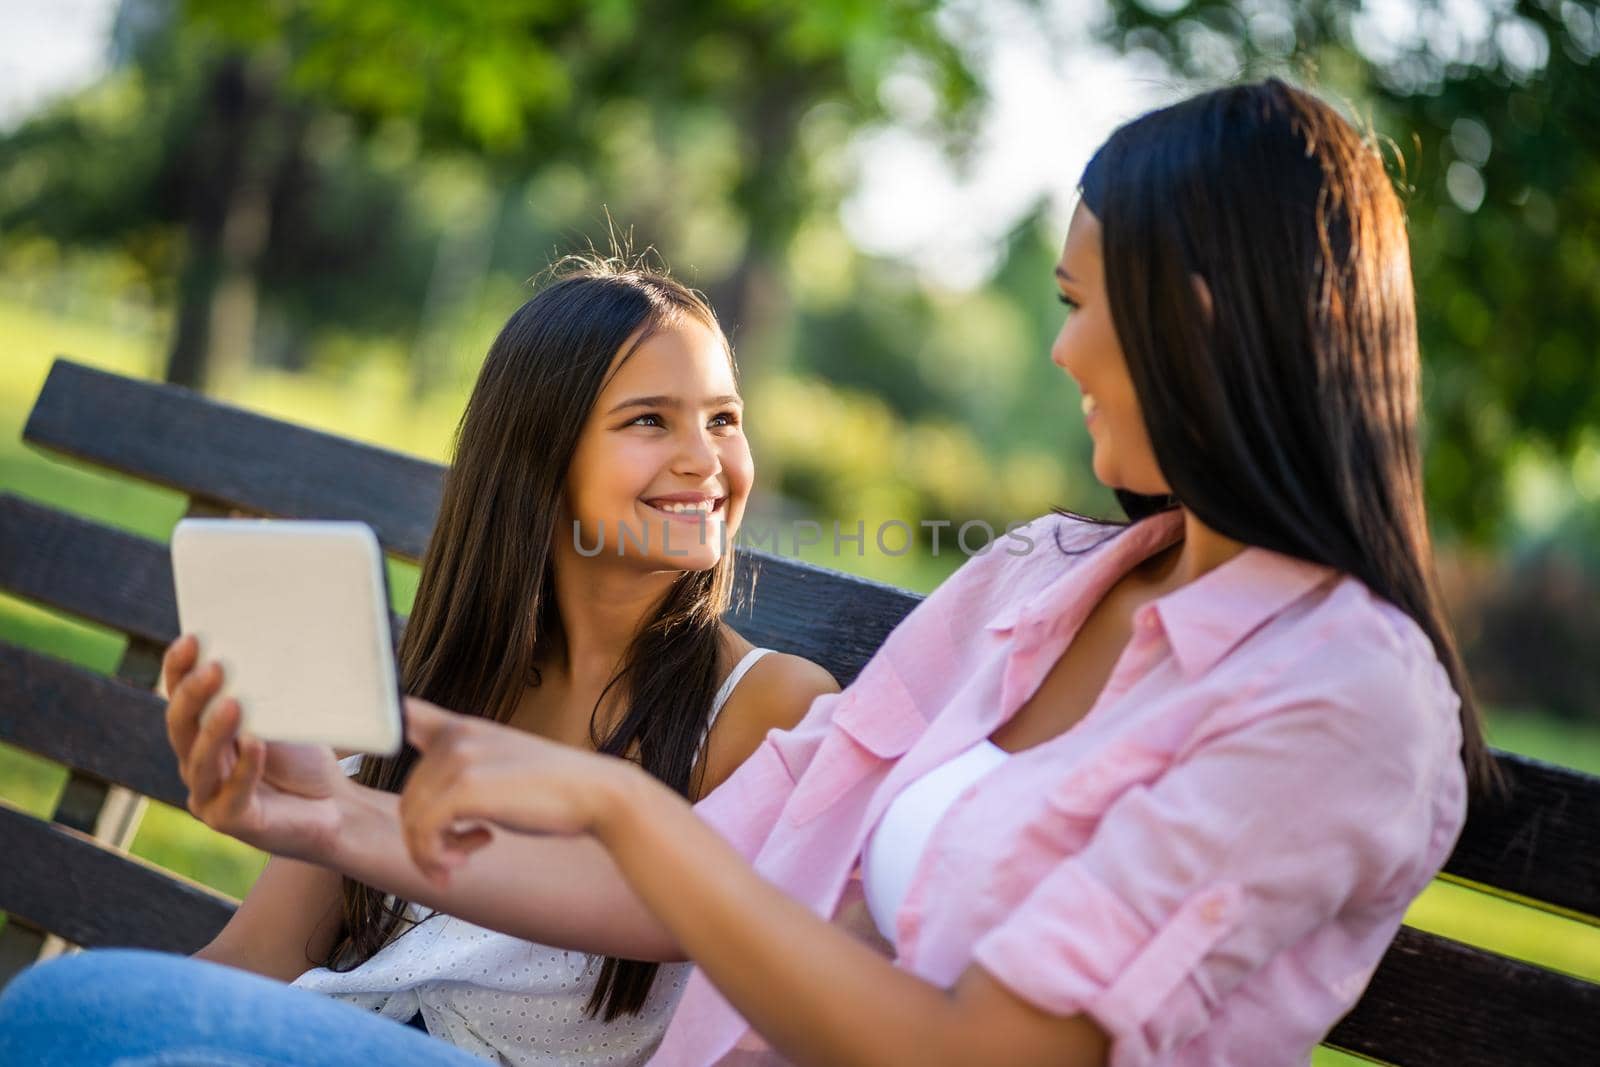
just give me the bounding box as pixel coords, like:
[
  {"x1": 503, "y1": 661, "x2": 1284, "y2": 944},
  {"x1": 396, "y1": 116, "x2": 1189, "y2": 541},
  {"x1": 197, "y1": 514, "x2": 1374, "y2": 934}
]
[{"x1": 1050, "y1": 202, "x2": 1171, "y2": 496}]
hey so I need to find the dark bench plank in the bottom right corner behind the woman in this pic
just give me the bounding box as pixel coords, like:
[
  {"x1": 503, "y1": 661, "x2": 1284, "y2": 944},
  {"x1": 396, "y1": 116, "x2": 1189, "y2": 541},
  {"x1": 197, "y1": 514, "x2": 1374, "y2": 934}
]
[{"x1": 1326, "y1": 928, "x2": 1600, "y2": 1067}]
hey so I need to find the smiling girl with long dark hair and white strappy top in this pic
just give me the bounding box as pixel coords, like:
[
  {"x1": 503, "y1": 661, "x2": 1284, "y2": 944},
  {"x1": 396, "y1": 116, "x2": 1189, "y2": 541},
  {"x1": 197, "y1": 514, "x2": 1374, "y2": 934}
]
[{"x1": 109, "y1": 258, "x2": 837, "y2": 1064}]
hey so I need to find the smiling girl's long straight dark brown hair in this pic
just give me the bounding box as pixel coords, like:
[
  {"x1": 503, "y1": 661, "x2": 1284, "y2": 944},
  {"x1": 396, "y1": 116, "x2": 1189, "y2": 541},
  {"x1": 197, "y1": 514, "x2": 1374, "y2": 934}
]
[{"x1": 325, "y1": 256, "x2": 748, "y2": 1022}]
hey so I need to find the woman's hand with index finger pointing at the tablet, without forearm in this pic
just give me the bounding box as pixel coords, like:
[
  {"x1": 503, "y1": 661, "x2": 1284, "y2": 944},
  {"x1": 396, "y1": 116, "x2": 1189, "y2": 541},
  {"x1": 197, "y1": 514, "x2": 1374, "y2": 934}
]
[{"x1": 400, "y1": 697, "x2": 637, "y2": 885}]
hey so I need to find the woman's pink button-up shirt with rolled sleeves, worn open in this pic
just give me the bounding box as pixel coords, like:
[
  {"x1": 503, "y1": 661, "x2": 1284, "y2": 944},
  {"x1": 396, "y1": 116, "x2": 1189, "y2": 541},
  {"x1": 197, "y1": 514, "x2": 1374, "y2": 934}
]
[{"x1": 651, "y1": 512, "x2": 1466, "y2": 1067}]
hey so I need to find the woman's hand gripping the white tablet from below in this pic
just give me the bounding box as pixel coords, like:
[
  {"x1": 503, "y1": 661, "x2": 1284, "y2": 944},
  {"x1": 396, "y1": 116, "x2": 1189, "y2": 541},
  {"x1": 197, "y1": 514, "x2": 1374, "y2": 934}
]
[{"x1": 162, "y1": 635, "x2": 344, "y2": 859}]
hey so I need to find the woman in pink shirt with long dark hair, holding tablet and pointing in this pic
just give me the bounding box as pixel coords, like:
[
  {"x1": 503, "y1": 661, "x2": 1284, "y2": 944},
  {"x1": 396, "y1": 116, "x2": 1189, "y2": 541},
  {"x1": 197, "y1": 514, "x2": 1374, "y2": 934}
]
[{"x1": 0, "y1": 80, "x2": 1491, "y2": 1065}]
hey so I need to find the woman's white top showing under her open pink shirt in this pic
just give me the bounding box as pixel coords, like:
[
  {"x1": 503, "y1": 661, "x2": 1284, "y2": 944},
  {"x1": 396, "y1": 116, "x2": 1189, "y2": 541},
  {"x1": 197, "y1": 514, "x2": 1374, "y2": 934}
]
[{"x1": 861, "y1": 739, "x2": 1011, "y2": 949}]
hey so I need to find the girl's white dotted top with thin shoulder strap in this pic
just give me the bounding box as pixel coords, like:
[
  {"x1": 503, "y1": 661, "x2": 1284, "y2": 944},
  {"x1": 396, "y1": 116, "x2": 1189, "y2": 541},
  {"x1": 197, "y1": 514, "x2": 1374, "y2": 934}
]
[{"x1": 294, "y1": 648, "x2": 771, "y2": 1067}]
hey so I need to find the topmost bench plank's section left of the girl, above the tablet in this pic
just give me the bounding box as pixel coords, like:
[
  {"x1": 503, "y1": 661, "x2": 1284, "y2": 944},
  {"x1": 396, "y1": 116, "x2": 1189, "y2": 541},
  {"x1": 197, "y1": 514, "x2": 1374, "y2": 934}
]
[{"x1": 22, "y1": 360, "x2": 443, "y2": 560}]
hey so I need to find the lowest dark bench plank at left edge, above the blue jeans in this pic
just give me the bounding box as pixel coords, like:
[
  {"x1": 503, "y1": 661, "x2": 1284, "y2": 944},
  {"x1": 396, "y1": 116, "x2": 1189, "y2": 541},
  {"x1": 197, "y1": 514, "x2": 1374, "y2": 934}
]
[{"x1": 0, "y1": 803, "x2": 234, "y2": 953}]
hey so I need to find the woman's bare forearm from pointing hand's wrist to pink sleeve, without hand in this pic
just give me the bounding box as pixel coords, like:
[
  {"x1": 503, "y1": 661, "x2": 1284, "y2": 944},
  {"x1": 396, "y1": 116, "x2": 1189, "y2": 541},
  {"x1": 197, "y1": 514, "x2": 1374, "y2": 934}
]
[{"x1": 595, "y1": 774, "x2": 1107, "y2": 1067}]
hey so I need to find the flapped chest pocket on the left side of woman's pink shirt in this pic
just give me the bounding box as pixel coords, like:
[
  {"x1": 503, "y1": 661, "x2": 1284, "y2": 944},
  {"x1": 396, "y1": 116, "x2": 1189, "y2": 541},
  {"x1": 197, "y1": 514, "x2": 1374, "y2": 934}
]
[{"x1": 787, "y1": 661, "x2": 928, "y2": 825}]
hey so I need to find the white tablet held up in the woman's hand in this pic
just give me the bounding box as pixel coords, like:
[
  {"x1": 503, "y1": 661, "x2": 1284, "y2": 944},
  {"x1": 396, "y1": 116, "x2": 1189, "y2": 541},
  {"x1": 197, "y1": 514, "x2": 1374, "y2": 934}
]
[{"x1": 173, "y1": 518, "x2": 405, "y2": 755}]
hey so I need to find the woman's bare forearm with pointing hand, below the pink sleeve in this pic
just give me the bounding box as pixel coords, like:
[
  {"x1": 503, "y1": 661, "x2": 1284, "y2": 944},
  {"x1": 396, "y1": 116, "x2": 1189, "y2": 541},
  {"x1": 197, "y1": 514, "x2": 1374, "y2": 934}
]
[{"x1": 400, "y1": 702, "x2": 1107, "y2": 1067}]
